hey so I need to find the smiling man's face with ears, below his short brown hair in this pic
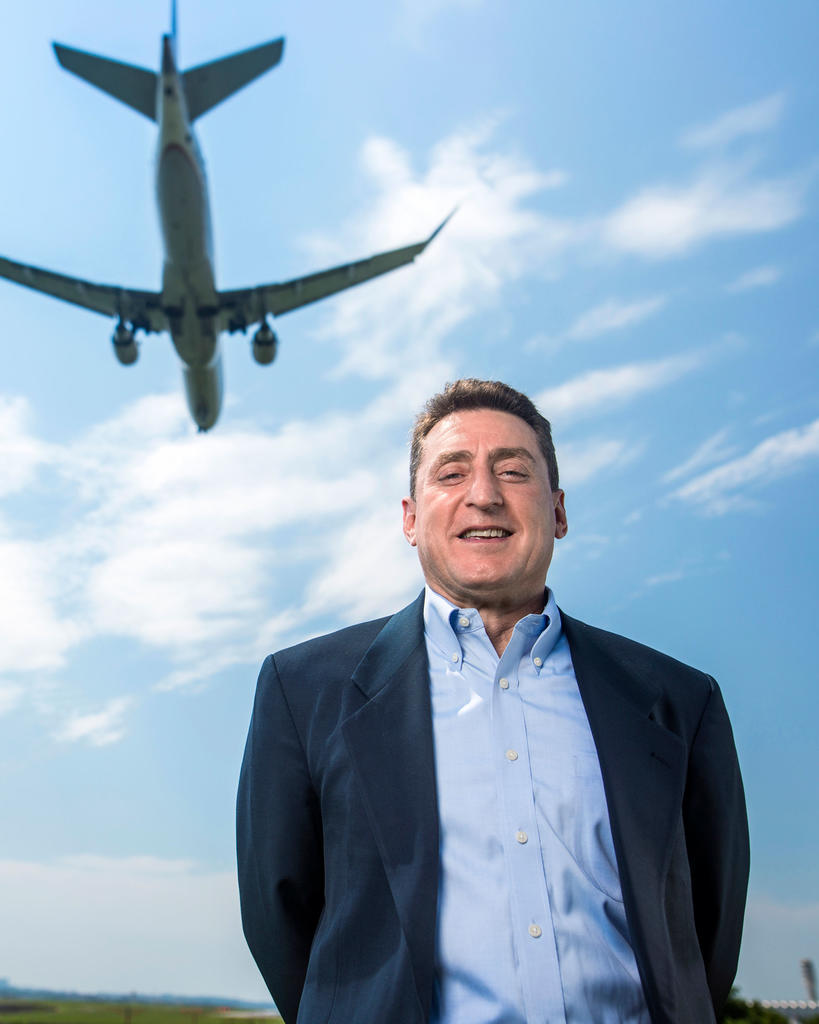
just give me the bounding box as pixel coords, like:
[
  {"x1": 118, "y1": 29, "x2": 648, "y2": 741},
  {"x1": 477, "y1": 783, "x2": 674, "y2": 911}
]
[{"x1": 402, "y1": 409, "x2": 568, "y2": 609}]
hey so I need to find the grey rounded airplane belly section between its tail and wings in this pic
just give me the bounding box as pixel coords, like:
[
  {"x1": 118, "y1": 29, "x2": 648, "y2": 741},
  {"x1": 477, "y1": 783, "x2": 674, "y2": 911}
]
[{"x1": 157, "y1": 144, "x2": 210, "y2": 266}]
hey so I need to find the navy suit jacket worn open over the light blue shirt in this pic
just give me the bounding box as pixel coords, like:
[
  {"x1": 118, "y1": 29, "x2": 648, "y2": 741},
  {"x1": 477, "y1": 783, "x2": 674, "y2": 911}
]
[{"x1": 236, "y1": 595, "x2": 748, "y2": 1024}]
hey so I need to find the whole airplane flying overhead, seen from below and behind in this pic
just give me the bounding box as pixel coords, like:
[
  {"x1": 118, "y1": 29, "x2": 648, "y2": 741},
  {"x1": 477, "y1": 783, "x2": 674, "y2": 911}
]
[{"x1": 0, "y1": 0, "x2": 455, "y2": 431}]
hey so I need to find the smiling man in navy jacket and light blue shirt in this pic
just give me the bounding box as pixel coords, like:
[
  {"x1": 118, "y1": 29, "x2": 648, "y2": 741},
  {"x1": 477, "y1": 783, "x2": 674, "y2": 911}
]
[{"x1": 238, "y1": 380, "x2": 748, "y2": 1024}]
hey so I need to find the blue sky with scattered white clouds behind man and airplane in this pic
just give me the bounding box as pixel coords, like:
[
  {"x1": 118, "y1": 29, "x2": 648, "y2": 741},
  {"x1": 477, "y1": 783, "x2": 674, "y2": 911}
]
[{"x1": 0, "y1": 0, "x2": 819, "y2": 998}]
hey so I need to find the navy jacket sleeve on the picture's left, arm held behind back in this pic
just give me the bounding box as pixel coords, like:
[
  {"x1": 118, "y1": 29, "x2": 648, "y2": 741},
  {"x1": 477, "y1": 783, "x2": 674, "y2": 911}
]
[{"x1": 236, "y1": 655, "x2": 324, "y2": 1021}]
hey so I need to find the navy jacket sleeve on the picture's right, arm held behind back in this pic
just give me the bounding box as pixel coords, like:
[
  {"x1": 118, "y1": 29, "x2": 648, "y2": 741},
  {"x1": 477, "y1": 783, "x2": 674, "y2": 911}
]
[{"x1": 683, "y1": 680, "x2": 749, "y2": 1016}]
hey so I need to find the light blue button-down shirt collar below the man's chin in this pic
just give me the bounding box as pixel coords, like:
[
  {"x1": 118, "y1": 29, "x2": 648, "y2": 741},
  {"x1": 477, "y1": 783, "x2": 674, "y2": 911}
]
[{"x1": 424, "y1": 586, "x2": 562, "y2": 673}]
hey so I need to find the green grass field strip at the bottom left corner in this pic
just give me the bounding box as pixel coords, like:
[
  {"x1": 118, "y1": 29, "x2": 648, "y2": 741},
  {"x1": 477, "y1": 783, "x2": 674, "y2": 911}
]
[{"x1": 0, "y1": 999, "x2": 282, "y2": 1024}]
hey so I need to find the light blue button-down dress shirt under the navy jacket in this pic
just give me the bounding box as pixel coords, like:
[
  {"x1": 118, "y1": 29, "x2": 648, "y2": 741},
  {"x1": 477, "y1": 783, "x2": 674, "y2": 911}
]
[{"x1": 424, "y1": 588, "x2": 650, "y2": 1024}]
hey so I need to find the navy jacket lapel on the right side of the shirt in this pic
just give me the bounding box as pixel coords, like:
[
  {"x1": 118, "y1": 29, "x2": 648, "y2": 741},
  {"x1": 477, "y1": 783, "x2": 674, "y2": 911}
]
[{"x1": 561, "y1": 612, "x2": 686, "y2": 1019}]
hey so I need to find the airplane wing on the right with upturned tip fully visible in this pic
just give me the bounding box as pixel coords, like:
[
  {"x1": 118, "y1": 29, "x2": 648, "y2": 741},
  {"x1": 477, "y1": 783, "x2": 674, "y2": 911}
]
[{"x1": 213, "y1": 210, "x2": 455, "y2": 331}]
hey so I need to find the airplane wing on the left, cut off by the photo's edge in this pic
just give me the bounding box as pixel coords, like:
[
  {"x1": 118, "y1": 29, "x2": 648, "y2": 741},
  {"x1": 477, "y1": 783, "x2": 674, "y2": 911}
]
[{"x1": 0, "y1": 256, "x2": 168, "y2": 331}]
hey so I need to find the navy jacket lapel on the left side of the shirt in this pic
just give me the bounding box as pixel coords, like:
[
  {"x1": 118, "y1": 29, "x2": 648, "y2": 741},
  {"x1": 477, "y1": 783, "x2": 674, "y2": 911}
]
[{"x1": 342, "y1": 593, "x2": 438, "y2": 1020}]
